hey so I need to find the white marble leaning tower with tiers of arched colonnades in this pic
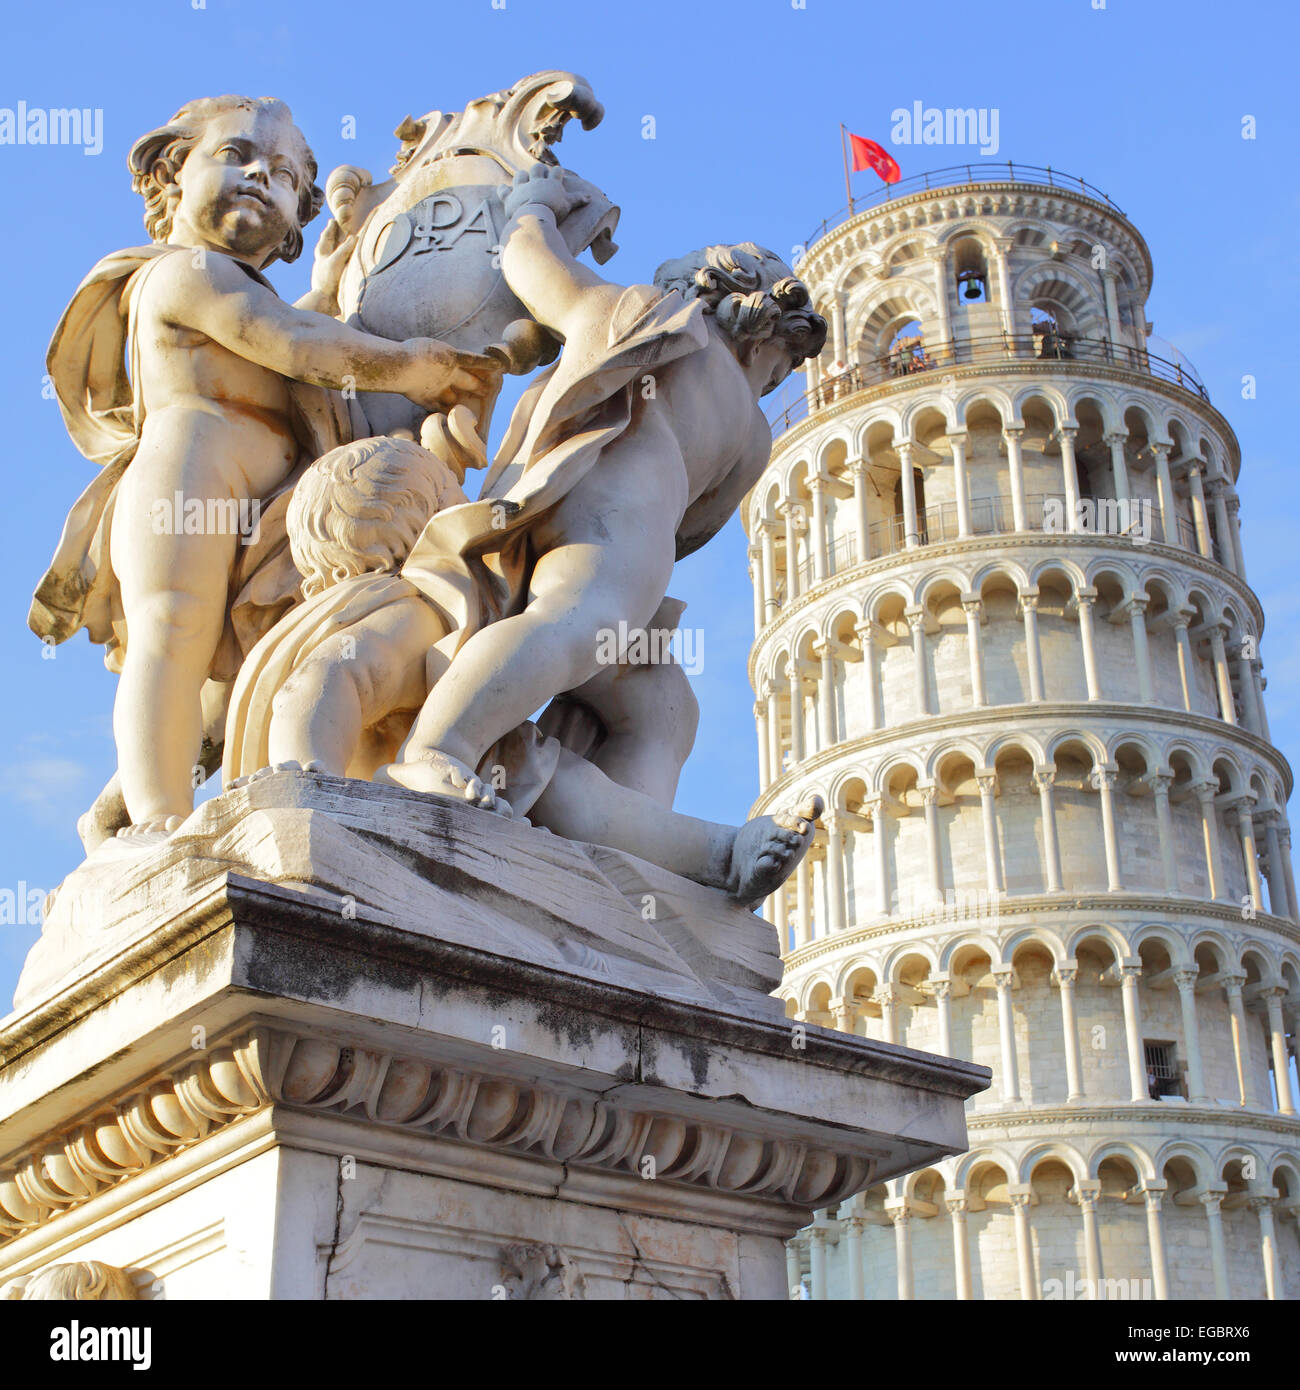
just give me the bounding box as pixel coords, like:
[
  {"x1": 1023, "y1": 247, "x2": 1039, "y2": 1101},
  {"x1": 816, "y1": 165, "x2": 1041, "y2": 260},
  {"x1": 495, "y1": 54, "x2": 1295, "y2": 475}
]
[{"x1": 744, "y1": 165, "x2": 1300, "y2": 1298}]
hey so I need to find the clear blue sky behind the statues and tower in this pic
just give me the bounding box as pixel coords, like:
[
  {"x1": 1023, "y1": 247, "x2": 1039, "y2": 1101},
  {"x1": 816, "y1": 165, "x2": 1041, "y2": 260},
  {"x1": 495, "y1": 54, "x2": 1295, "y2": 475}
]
[{"x1": 0, "y1": 0, "x2": 1300, "y2": 1009}]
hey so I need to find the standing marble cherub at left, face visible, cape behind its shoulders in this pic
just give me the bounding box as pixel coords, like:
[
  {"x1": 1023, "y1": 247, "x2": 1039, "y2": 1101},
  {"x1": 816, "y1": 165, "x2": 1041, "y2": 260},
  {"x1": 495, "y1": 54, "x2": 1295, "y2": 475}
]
[{"x1": 29, "y1": 96, "x2": 499, "y2": 831}]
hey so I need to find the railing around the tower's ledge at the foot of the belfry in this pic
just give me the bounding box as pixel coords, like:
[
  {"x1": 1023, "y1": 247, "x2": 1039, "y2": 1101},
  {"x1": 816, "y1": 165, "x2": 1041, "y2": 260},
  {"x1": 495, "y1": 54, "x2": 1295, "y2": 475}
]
[{"x1": 772, "y1": 332, "x2": 1210, "y2": 438}]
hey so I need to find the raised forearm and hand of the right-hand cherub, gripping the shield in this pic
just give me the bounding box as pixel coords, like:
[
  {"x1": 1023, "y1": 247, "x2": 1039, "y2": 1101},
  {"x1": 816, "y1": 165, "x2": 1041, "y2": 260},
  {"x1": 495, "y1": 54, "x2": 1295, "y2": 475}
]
[{"x1": 501, "y1": 168, "x2": 623, "y2": 341}]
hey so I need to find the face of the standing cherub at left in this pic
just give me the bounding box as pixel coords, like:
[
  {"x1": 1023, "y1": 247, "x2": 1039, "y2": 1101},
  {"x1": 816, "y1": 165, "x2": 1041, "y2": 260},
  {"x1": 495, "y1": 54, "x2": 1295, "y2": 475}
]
[{"x1": 168, "y1": 111, "x2": 307, "y2": 267}]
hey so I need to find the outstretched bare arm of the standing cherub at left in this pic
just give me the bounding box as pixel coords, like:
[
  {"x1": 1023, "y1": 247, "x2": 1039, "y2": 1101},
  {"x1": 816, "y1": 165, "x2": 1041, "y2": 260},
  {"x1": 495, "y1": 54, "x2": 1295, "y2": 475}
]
[{"x1": 149, "y1": 253, "x2": 499, "y2": 409}]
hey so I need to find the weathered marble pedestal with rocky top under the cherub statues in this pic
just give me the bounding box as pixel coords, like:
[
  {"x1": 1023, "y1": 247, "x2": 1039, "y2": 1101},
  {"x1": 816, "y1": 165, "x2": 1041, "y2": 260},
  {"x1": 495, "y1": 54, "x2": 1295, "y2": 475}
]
[{"x1": 0, "y1": 773, "x2": 989, "y2": 1298}]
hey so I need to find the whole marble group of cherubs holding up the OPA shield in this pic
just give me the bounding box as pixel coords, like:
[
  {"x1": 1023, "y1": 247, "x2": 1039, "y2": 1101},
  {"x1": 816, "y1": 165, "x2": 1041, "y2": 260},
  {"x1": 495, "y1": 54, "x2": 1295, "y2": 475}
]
[{"x1": 29, "y1": 81, "x2": 826, "y2": 906}]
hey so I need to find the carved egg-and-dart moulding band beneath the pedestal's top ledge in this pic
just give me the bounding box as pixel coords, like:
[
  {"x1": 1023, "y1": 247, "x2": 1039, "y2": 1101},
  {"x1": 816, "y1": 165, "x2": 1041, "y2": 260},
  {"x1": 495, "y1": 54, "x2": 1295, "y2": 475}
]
[{"x1": 0, "y1": 1027, "x2": 875, "y2": 1243}]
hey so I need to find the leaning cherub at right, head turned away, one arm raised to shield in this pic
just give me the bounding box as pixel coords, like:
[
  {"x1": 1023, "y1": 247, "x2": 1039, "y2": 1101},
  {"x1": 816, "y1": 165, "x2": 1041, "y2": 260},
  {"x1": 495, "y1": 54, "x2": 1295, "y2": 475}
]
[{"x1": 385, "y1": 168, "x2": 826, "y2": 795}]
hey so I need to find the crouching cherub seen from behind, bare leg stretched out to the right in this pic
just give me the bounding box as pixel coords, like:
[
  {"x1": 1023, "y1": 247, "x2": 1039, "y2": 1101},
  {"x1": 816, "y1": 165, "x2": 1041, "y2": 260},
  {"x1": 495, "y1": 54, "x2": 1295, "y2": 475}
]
[{"x1": 222, "y1": 436, "x2": 822, "y2": 906}]
